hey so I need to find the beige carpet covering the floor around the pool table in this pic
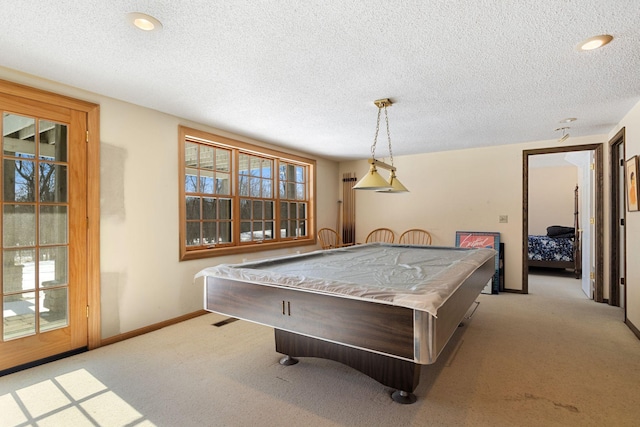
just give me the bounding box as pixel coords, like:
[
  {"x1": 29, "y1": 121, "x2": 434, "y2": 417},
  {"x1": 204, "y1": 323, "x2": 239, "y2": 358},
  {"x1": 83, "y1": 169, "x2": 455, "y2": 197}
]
[{"x1": 0, "y1": 275, "x2": 640, "y2": 427}]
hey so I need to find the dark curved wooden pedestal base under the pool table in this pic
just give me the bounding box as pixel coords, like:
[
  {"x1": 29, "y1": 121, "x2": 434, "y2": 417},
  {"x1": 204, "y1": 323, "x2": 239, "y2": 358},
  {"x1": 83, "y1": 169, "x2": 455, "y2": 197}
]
[{"x1": 275, "y1": 329, "x2": 421, "y2": 404}]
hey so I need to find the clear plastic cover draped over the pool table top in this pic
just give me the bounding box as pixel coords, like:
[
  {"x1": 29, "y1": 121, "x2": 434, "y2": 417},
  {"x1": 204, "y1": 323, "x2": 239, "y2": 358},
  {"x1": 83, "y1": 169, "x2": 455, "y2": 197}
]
[{"x1": 196, "y1": 243, "x2": 495, "y2": 317}]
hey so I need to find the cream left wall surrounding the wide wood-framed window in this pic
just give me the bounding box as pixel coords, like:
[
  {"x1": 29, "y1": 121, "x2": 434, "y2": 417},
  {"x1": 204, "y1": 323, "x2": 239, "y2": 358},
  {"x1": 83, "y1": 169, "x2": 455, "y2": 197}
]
[{"x1": 0, "y1": 68, "x2": 338, "y2": 338}]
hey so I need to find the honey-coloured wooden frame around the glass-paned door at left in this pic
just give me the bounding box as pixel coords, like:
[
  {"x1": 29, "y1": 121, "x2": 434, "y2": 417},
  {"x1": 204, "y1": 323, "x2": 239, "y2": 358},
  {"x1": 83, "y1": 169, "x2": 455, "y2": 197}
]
[{"x1": 0, "y1": 79, "x2": 101, "y2": 350}]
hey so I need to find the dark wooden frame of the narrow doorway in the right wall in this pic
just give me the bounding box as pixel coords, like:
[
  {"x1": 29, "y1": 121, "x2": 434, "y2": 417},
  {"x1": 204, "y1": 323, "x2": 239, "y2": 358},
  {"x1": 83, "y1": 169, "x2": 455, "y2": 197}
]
[{"x1": 609, "y1": 128, "x2": 627, "y2": 314}]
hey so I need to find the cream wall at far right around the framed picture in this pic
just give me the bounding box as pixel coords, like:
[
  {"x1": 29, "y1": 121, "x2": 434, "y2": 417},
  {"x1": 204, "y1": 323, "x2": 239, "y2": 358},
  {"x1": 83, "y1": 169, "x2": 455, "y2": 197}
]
[{"x1": 609, "y1": 102, "x2": 640, "y2": 329}]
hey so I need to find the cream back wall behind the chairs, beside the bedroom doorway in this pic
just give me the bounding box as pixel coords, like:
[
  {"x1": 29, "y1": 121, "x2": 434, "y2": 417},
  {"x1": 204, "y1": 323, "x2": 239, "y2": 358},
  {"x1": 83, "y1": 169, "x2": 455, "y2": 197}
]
[{"x1": 340, "y1": 135, "x2": 608, "y2": 290}]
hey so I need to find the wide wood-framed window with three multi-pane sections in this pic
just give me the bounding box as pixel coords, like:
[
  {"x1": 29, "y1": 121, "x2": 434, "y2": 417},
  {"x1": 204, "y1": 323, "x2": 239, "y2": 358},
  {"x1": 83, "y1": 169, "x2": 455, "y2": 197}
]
[{"x1": 179, "y1": 127, "x2": 315, "y2": 260}]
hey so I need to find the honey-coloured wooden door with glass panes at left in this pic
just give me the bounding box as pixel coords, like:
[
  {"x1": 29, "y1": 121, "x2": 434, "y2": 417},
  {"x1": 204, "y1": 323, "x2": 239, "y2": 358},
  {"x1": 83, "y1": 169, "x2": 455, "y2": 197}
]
[{"x1": 0, "y1": 94, "x2": 87, "y2": 370}]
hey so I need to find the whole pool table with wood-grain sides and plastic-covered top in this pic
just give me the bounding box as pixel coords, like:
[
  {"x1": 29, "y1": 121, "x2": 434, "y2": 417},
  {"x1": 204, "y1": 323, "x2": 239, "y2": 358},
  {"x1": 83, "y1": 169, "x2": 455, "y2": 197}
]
[{"x1": 196, "y1": 243, "x2": 495, "y2": 403}]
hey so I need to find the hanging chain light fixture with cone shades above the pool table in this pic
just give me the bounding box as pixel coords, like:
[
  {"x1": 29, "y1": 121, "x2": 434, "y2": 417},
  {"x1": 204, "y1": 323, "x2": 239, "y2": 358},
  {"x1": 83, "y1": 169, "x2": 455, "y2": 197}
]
[{"x1": 353, "y1": 98, "x2": 409, "y2": 193}]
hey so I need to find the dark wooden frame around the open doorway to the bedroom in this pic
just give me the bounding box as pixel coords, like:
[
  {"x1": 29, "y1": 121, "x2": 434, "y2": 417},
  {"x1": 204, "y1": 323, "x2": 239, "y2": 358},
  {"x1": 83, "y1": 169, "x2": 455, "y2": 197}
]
[{"x1": 521, "y1": 144, "x2": 604, "y2": 302}]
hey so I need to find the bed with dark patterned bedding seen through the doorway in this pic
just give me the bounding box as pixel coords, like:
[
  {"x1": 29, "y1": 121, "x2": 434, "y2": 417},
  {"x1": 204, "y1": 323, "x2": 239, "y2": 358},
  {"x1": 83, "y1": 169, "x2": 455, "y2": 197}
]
[{"x1": 527, "y1": 186, "x2": 582, "y2": 279}]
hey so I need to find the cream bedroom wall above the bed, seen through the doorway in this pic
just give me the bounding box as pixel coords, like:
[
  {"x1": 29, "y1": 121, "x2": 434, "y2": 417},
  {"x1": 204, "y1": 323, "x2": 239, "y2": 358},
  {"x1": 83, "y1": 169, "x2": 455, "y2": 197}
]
[{"x1": 529, "y1": 166, "x2": 578, "y2": 236}]
